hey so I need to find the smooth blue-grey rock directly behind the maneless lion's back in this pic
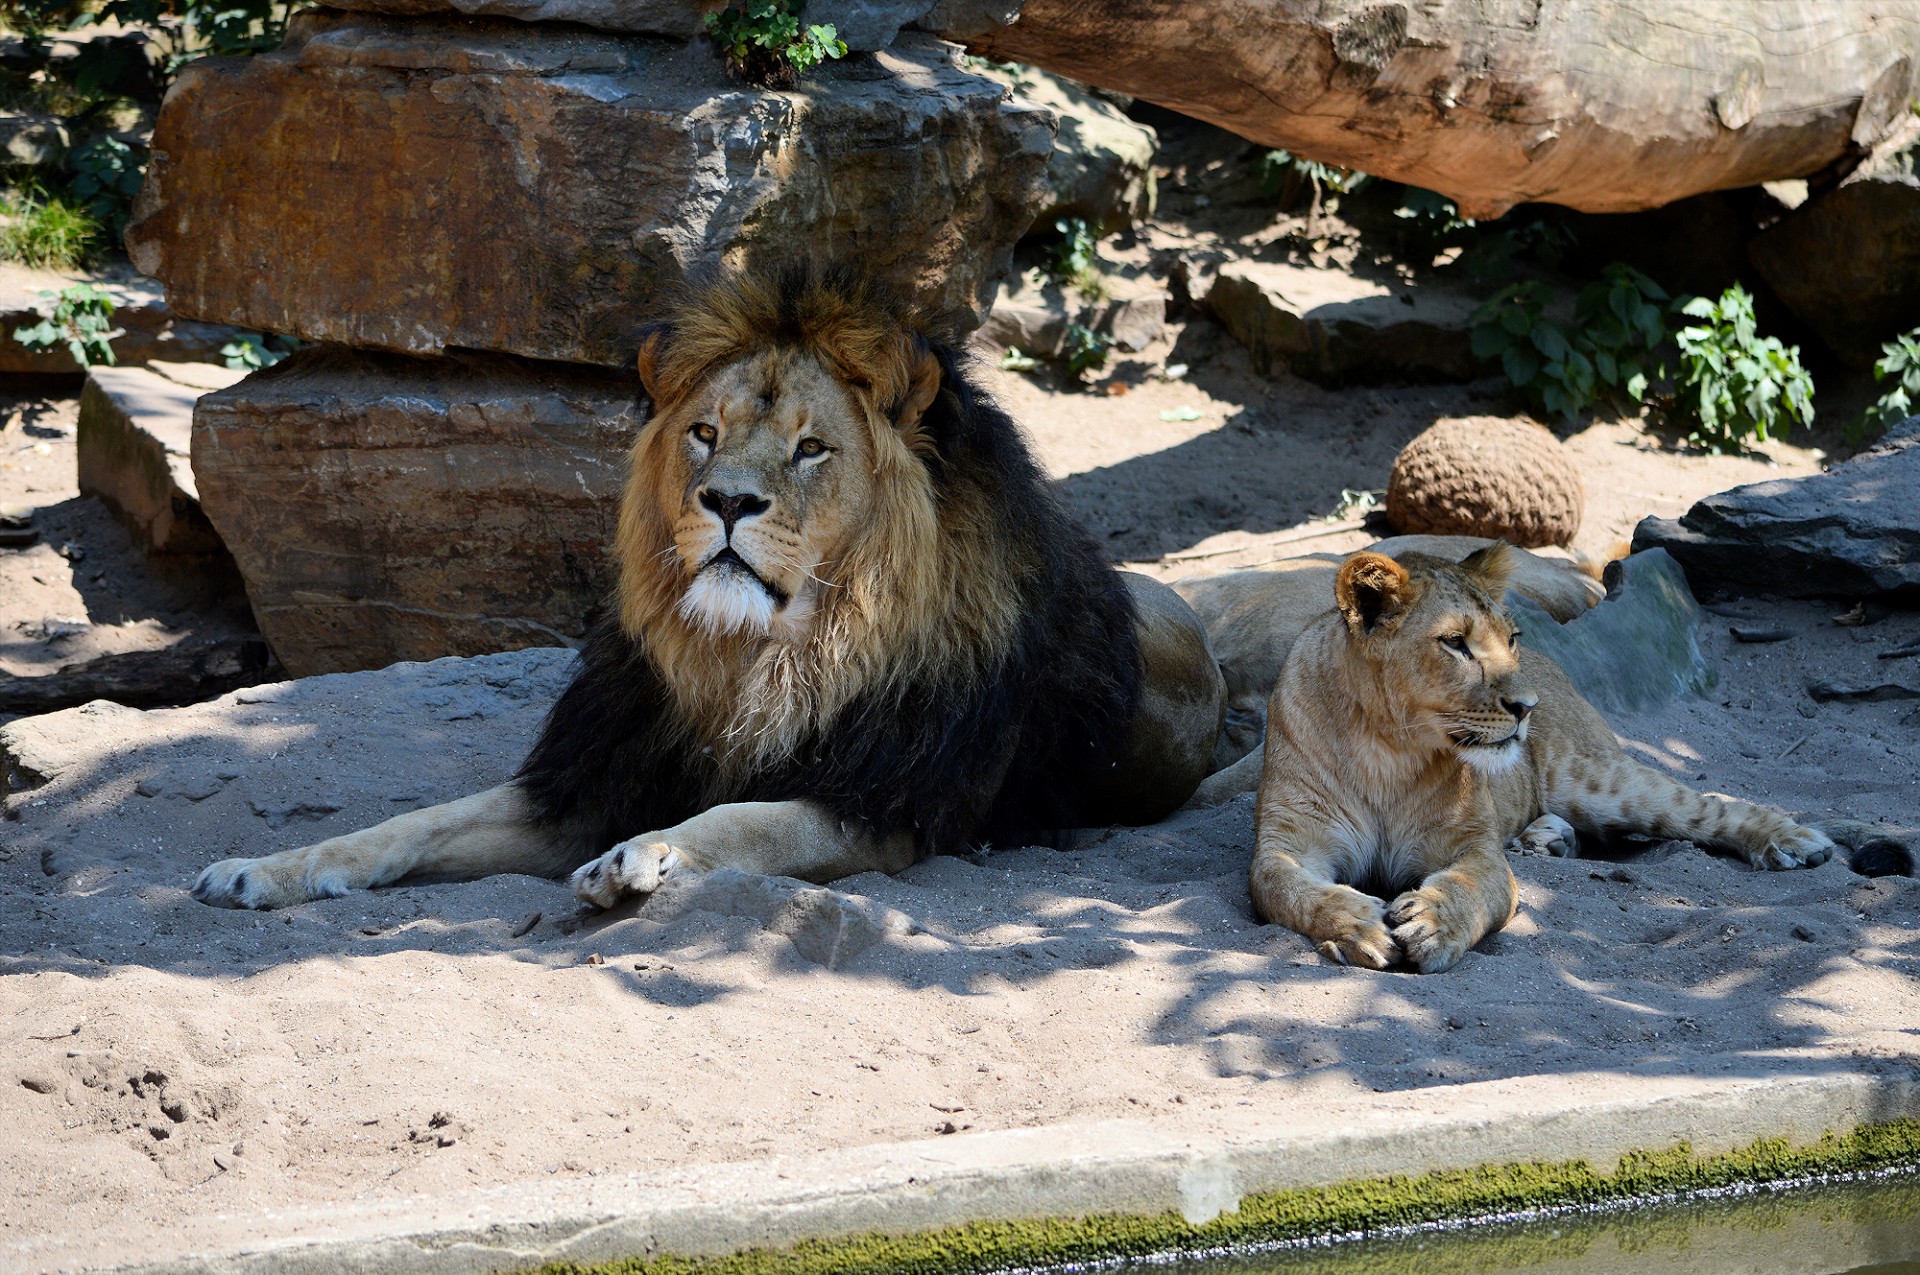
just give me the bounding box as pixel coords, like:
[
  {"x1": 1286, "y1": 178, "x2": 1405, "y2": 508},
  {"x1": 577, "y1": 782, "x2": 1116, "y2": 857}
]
[{"x1": 1505, "y1": 549, "x2": 1718, "y2": 712}]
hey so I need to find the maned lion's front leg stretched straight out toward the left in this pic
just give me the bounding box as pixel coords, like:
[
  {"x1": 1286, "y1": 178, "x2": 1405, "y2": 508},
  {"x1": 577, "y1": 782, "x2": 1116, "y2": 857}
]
[{"x1": 194, "y1": 783, "x2": 580, "y2": 908}]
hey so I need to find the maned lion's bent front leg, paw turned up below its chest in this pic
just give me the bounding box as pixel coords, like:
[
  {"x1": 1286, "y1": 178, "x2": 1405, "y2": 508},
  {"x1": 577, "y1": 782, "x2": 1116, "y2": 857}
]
[{"x1": 570, "y1": 801, "x2": 918, "y2": 908}]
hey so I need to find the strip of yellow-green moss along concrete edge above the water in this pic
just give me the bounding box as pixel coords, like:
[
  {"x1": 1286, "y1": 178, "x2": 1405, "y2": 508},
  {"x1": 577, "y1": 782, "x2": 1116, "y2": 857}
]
[{"x1": 541, "y1": 1119, "x2": 1920, "y2": 1275}]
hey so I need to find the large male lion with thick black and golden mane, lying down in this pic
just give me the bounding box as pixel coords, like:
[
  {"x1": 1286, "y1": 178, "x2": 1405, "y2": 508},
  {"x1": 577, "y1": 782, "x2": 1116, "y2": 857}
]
[{"x1": 194, "y1": 273, "x2": 1225, "y2": 908}]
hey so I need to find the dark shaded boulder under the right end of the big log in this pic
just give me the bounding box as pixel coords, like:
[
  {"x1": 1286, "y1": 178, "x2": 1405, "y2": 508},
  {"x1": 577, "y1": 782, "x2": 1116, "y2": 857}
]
[{"x1": 1747, "y1": 150, "x2": 1920, "y2": 367}]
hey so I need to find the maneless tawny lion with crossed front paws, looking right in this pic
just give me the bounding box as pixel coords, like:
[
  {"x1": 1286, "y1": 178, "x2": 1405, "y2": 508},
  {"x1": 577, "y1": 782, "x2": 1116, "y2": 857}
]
[{"x1": 1252, "y1": 543, "x2": 1834, "y2": 974}]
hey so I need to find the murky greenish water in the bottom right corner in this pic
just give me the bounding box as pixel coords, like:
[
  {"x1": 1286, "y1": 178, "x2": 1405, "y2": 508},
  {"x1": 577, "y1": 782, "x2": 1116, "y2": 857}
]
[{"x1": 1127, "y1": 1171, "x2": 1920, "y2": 1275}]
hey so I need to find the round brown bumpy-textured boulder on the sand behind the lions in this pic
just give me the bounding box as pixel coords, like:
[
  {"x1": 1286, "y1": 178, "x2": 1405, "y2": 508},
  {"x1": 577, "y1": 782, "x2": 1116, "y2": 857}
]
[{"x1": 1386, "y1": 417, "x2": 1586, "y2": 549}]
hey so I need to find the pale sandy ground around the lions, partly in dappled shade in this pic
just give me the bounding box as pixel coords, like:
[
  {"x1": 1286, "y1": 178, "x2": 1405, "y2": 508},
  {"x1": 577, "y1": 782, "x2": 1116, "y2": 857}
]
[{"x1": 0, "y1": 332, "x2": 1920, "y2": 1271}]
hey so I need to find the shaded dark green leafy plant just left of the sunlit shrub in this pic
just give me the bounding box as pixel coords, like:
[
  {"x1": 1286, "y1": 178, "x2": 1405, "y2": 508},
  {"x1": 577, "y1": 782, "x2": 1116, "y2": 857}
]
[{"x1": 1471, "y1": 263, "x2": 1667, "y2": 421}]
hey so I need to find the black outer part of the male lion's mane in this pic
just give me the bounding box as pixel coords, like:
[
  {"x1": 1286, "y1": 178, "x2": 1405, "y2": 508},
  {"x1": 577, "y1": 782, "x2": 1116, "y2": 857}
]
[{"x1": 518, "y1": 288, "x2": 1142, "y2": 867}]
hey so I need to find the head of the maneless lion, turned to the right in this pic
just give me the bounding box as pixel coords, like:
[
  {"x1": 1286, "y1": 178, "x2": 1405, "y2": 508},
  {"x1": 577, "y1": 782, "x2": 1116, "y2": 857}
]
[{"x1": 1334, "y1": 545, "x2": 1538, "y2": 772}]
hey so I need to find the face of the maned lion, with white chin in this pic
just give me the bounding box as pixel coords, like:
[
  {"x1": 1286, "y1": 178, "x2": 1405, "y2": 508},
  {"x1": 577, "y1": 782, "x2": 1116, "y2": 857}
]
[{"x1": 659, "y1": 349, "x2": 872, "y2": 639}]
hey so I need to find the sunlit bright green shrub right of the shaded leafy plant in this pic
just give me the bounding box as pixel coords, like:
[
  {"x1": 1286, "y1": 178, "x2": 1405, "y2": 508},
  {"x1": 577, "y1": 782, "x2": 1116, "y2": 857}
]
[{"x1": 1668, "y1": 284, "x2": 1812, "y2": 451}]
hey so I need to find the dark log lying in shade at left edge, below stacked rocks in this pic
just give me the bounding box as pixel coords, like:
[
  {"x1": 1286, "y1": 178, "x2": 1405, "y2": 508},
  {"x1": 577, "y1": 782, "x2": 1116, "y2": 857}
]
[{"x1": 0, "y1": 638, "x2": 278, "y2": 712}]
